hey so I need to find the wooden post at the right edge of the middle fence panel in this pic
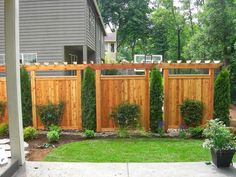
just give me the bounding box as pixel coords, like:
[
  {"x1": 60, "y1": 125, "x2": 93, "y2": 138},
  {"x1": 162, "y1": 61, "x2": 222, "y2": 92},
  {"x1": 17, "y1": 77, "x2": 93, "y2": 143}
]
[{"x1": 145, "y1": 69, "x2": 150, "y2": 131}]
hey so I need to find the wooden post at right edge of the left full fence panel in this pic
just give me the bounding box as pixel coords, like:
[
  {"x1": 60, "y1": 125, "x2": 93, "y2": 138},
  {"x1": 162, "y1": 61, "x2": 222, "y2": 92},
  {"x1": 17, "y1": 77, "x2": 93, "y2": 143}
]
[{"x1": 76, "y1": 70, "x2": 82, "y2": 130}]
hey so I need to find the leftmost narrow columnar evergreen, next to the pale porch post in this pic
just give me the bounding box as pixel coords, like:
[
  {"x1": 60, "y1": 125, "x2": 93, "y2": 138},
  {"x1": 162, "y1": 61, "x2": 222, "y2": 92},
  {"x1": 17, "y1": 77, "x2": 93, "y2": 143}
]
[{"x1": 20, "y1": 67, "x2": 32, "y2": 127}]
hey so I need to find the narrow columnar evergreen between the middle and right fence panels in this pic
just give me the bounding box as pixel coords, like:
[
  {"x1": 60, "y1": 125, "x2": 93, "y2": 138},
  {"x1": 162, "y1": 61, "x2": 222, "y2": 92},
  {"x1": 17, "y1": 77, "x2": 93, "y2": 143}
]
[{"x1": 150, "y1": 68, "x2": 163, "y2": 132}]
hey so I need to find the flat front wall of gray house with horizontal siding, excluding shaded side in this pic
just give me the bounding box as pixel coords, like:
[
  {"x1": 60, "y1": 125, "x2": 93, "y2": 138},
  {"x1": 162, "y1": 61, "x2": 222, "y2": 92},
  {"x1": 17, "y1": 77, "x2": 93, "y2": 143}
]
[{"x1": 0, "y1": 0, "x2": 86, "y2": 62}]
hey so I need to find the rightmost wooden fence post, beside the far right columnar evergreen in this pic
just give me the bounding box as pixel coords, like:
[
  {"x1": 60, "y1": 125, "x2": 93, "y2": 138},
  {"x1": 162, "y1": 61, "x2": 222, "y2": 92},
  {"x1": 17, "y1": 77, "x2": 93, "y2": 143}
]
[{"x1": 208, "y1": 68, "x2": 215, "y2": 120}]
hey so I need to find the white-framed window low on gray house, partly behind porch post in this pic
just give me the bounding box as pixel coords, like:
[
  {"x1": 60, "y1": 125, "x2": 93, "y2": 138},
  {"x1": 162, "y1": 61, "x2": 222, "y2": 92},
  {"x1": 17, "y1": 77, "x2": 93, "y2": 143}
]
[{"x1": 0, "y1": 53, "x2": 37, "y2": 64}]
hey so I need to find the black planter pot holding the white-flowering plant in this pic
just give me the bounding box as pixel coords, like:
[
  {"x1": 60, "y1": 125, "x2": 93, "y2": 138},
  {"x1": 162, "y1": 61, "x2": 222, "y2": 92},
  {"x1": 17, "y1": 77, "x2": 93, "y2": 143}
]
[{"x1": 211, "y1": 149, "x2": 235, "y2": 168}]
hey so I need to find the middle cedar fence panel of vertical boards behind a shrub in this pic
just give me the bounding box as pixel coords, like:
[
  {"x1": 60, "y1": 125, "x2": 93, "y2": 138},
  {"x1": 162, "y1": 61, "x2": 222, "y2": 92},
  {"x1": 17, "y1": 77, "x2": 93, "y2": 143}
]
[{"x1": 97, "y1": 75, "x2": 149, "y2": 131}]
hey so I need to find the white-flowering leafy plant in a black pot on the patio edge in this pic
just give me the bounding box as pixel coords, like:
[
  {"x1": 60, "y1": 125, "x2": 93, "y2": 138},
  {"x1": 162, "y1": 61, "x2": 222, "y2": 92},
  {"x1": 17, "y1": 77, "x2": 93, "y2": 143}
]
[{"x1": 203, "y1": 119, "x2": 236, "y2": 168}]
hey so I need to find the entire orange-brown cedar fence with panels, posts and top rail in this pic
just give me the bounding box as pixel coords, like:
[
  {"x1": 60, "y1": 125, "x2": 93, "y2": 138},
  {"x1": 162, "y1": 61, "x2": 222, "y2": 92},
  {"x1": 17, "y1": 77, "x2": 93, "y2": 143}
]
[{"x1": 0, "y1": 63, "x2": 221, "y2": 132}]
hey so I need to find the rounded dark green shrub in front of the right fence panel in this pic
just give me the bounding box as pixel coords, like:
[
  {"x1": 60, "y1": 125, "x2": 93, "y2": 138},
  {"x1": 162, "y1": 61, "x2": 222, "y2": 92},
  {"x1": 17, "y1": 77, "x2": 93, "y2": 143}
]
[{"x1": 180, "y1": 99, "x2": 204, "y2": 127}]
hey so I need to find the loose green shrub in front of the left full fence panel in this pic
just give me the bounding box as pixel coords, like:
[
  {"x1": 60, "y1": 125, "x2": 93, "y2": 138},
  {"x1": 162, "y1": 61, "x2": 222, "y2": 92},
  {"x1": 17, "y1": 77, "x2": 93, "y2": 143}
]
[{"x1": 37, "y1": 102, "x2": 65, "y2": 128}]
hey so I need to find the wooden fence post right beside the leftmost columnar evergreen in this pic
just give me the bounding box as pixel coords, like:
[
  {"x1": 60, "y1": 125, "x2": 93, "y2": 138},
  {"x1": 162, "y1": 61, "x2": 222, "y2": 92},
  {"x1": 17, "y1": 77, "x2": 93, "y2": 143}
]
[{"x1": 30, "y1": 71, "x2": 38, "y2": 128}]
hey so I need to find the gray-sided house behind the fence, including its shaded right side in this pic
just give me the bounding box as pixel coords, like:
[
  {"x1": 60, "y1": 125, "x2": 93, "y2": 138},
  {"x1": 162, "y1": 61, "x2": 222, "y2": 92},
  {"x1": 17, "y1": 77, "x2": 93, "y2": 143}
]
[{"x1": 0, "y1": 0, "x2": 105, "y2": 63}]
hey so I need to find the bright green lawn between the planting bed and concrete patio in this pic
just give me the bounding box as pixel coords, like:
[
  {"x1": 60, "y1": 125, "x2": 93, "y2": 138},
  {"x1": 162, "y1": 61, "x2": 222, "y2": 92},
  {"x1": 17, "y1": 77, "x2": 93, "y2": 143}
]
[{"x1": 45, "y1": 138, "x2": 236, "y2": 162}]
